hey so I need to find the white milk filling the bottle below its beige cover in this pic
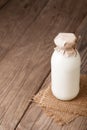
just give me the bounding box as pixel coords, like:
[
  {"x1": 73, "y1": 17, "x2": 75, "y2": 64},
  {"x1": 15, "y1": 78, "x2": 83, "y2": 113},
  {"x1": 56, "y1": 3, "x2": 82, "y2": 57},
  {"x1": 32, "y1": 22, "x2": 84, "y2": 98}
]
[{"x1": 51, "y1": 33, "x2": 81, "y2": 100}]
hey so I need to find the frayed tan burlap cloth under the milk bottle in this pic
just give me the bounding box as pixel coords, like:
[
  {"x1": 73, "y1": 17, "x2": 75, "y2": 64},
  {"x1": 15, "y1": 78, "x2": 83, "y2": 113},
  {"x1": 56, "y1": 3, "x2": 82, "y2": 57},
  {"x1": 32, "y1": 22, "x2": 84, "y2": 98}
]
[{"x1": 34, "y1": 75, "x2": 87, "y2": 125}]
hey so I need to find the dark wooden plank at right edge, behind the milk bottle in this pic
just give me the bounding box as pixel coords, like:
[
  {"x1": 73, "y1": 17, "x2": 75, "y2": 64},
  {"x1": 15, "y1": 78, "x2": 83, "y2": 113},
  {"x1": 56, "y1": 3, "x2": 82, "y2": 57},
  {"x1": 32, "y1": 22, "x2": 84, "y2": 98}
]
[{"x1": 76, "y1": 16, "x2": 87, "y2": 74}]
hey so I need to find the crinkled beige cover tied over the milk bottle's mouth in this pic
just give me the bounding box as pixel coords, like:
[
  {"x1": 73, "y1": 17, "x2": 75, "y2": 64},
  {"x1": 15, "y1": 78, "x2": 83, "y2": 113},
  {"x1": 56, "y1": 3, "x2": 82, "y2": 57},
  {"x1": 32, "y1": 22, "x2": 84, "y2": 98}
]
[{"x1": 54, "y1": 33, "x2": 77, "y2": 56}]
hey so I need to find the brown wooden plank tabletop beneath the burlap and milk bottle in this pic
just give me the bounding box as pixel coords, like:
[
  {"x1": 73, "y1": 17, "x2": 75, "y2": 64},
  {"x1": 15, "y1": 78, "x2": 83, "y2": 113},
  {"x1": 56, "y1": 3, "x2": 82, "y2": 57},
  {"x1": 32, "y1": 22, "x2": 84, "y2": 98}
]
[{"x1": 0, "y1": 0, "x2": 87, "y2": 130}]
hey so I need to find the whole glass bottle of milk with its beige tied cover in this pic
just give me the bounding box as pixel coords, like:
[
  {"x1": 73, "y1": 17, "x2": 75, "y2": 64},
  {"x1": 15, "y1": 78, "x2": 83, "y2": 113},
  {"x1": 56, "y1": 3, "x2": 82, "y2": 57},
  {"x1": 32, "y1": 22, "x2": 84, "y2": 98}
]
[{"x1": 51, "y1": 33, "x2": 81, "y2": 100}]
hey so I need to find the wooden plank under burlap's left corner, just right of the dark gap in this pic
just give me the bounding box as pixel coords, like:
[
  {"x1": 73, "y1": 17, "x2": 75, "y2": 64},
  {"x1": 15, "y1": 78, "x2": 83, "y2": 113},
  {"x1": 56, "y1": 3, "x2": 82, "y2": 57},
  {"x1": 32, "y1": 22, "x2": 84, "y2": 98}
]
[{"x1": 17, "y1": 75, "x2": 52, "y2": 130}]
